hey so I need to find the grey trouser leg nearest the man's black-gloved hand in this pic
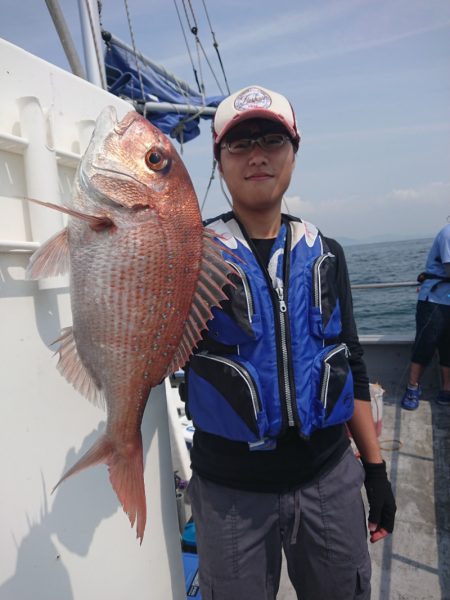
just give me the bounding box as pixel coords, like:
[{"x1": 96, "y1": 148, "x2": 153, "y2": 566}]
[{"x1": 281, "y1": 448, "x2": 371, "y2": 600}]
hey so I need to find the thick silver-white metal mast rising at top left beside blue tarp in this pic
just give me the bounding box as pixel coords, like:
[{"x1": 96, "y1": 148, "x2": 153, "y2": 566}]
[{"x1": 78, "y1": 0, "x2": 106, "y2": 89}]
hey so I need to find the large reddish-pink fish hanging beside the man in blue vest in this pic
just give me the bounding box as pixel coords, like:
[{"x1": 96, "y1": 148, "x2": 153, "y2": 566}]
[{"x1": 27, "y1": 106, "x2": 235, "y2": 544}]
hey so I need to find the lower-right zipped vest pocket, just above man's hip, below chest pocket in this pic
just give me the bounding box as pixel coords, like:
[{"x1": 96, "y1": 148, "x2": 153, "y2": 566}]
[{"x1": 312, "y1": 344, "x2": 354, "y2": 429}]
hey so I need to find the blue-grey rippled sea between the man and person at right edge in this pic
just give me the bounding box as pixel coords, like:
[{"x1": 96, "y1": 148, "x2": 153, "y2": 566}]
[{"x1": 344, "y1": 238, "x2": 433, "y2": 337}]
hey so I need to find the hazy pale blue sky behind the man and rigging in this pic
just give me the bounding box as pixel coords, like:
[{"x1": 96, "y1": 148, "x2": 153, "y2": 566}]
[{"x1": 0, "y1": 0, "x2": 450, "y2": 242}]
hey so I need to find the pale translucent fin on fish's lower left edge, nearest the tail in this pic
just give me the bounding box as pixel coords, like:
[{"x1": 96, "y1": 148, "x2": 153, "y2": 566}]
[{"x1": 54, "y1": 327, "x2": 105, "y2": 408}]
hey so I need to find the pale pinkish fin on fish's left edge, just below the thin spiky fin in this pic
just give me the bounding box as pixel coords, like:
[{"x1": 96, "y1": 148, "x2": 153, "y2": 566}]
[{"x1": 26, "y1": 227, "x2": 70, "y2": 279}]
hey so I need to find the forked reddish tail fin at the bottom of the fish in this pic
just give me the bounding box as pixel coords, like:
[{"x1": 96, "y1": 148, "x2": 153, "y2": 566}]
[{"x1": 52, "y1": 431, "x2": 147, "y2": 544}]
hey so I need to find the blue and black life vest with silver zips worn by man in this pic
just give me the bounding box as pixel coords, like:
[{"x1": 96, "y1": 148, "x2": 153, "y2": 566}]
[{"x1": 186, "y1": 213, "x2": 353, "y2": 449}]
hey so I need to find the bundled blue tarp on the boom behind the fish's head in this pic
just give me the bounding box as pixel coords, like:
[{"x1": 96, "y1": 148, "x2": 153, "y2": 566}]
[{"x1": 105, "y1": 40, "x2": 224, "y2": 143}]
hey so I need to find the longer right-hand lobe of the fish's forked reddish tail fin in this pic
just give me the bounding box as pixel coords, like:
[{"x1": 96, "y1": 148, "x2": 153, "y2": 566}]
[{"x1": 107, "y1": 431, "x2": 147, "y2": 544}]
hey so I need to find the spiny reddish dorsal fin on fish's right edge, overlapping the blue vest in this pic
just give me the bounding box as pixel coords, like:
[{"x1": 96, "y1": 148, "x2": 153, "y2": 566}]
[{"x1": 165, "y1": 229, "x2": 236, "y2": 377}]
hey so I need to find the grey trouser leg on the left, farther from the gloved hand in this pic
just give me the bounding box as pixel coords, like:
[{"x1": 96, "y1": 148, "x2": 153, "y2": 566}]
[{"x1": 188, "y1": 474, "x2": 281, "y2": 600}]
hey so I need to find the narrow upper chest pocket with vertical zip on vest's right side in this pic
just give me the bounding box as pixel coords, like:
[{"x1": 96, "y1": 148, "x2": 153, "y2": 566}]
[{"x1": 307, "y1": 252, "x2": 342, "y2": 340}]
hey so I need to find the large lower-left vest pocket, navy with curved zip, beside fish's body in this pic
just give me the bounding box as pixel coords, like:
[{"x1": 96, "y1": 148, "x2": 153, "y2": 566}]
[{"x1": 187, "y1": 352, "x2": 268, "y2": 443}]
